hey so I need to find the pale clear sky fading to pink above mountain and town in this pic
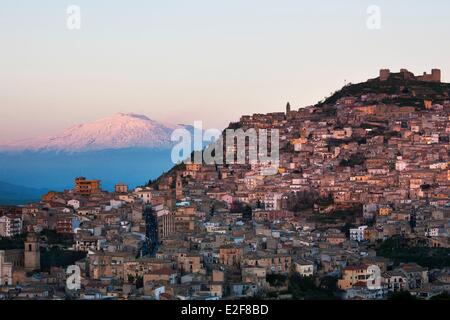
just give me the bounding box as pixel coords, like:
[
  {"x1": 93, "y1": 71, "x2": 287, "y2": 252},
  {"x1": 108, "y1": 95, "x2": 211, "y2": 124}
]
[{"x1": 0, "y1": 0, "x2": 450, "y2": 142}]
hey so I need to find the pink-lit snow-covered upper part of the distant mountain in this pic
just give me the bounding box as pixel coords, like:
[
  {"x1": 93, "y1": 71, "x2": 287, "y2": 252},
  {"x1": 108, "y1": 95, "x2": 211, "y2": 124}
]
[{"x1": 0, "y1": 113, "x2": 190, "y2": 152}]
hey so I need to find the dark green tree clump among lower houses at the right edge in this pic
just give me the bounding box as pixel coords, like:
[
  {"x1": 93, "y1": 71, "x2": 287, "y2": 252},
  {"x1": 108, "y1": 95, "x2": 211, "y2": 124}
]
[{"x1": 377, "y1": 236, "x2": 450, "y2": 269}]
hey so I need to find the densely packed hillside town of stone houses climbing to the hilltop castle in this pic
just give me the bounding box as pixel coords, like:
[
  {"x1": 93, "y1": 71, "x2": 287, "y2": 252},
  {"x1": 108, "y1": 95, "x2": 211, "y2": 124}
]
[{"x1": 0, "y1": 69, "x2": 450, "y2": 300}]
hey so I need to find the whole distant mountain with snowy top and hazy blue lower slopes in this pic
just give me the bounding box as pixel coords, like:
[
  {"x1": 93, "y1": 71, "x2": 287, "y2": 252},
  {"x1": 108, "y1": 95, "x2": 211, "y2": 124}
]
[{"x1": 0, "y1": 113, "x2": 200, "y2": 198}]
